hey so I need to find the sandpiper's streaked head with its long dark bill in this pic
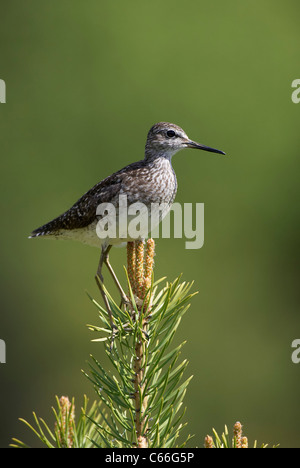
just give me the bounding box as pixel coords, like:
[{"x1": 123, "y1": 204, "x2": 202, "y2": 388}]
[{"x1": 146, "y1": 122, "x2": 225, "y2": 159}]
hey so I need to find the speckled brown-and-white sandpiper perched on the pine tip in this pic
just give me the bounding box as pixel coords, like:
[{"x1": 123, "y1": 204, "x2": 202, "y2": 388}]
[{"x1": 29, "y1": 122, "x2": 225, "y2": 324}]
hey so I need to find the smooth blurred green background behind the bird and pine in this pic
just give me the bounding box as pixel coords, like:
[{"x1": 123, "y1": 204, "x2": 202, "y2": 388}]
[{"x1": 0, "y1": 0, "x2": 300, "y2": 447}]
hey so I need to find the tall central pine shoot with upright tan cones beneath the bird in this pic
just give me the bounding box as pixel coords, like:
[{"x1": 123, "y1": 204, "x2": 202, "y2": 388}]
[{"x1": 85, "y1": 239, "x2": 193, "y2": 448}]
